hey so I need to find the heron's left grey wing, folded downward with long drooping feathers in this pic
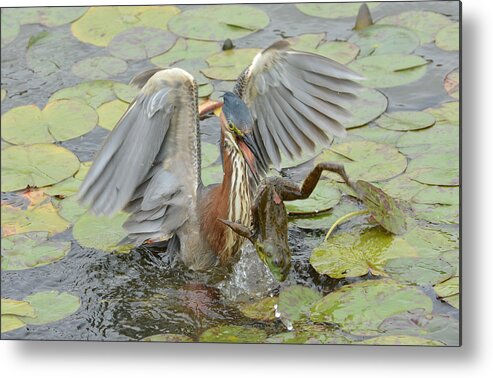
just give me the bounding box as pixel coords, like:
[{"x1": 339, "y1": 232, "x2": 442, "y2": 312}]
[{"x1": 79, "y1": 68, "x2": 200, "y2": 244}]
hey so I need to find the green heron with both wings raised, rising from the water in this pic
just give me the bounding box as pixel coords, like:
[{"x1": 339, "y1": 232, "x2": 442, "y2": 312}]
[{"x1": 79, "y1": 41, "x2": 362, "y2": 270}]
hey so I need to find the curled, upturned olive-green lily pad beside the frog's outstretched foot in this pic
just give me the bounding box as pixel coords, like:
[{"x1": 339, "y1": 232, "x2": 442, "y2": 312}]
[{"x1": 354, "y1": 180, "x2": 407, "y2": 235}]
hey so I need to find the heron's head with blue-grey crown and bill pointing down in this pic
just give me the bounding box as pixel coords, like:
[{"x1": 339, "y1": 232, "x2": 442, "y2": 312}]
[{"x1": 221, "y1": 92, "x2": 259, "y2": 178}]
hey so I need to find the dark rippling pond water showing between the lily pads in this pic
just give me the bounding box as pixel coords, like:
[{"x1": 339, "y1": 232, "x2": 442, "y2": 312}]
[{"x1": 1, "y1": 1, "x2": 459, "y2": 344}]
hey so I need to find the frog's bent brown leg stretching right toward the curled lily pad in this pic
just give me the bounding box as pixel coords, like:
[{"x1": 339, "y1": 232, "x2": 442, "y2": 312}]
[{"x1": 274, "y1": 163, "x2": 350, "y2": 201}]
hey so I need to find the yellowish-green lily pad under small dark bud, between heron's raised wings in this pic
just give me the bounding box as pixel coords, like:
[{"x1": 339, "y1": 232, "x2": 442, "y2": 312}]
[{"x1": 202, "y1": 49, "x2": 261, "y2": 80}]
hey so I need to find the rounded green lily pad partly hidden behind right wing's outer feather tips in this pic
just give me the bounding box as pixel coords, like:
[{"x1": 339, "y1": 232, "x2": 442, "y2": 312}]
[{"x1": 343, "y1": 88, "x2": 388, "y2": 129}]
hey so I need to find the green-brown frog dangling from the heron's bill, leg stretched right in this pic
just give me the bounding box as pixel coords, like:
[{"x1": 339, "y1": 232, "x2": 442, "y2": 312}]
[{"x1": 218, "y1": 162, "x2": 349, "y2": 282}]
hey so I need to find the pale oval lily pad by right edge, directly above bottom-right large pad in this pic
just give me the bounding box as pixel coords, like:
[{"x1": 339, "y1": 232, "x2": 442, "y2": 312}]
[{"x1": 385, "y1": 258, "x2": 455, "y2": 285}]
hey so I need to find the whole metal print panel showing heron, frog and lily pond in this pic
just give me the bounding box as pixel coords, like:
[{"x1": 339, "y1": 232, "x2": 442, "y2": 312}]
[{"x1": 1, "y1": 1, "x2": 461, "y2": 346}]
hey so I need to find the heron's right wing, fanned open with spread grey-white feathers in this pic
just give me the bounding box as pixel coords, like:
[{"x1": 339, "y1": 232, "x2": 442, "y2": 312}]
[{"x1": 235, "y1": 40, "x2": 362, "y2": 167}]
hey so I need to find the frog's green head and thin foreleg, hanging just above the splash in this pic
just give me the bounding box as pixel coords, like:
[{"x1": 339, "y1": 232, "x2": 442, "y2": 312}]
[{"x1": 218, "y1": 218, "x2": 291, "y2": 282}]
